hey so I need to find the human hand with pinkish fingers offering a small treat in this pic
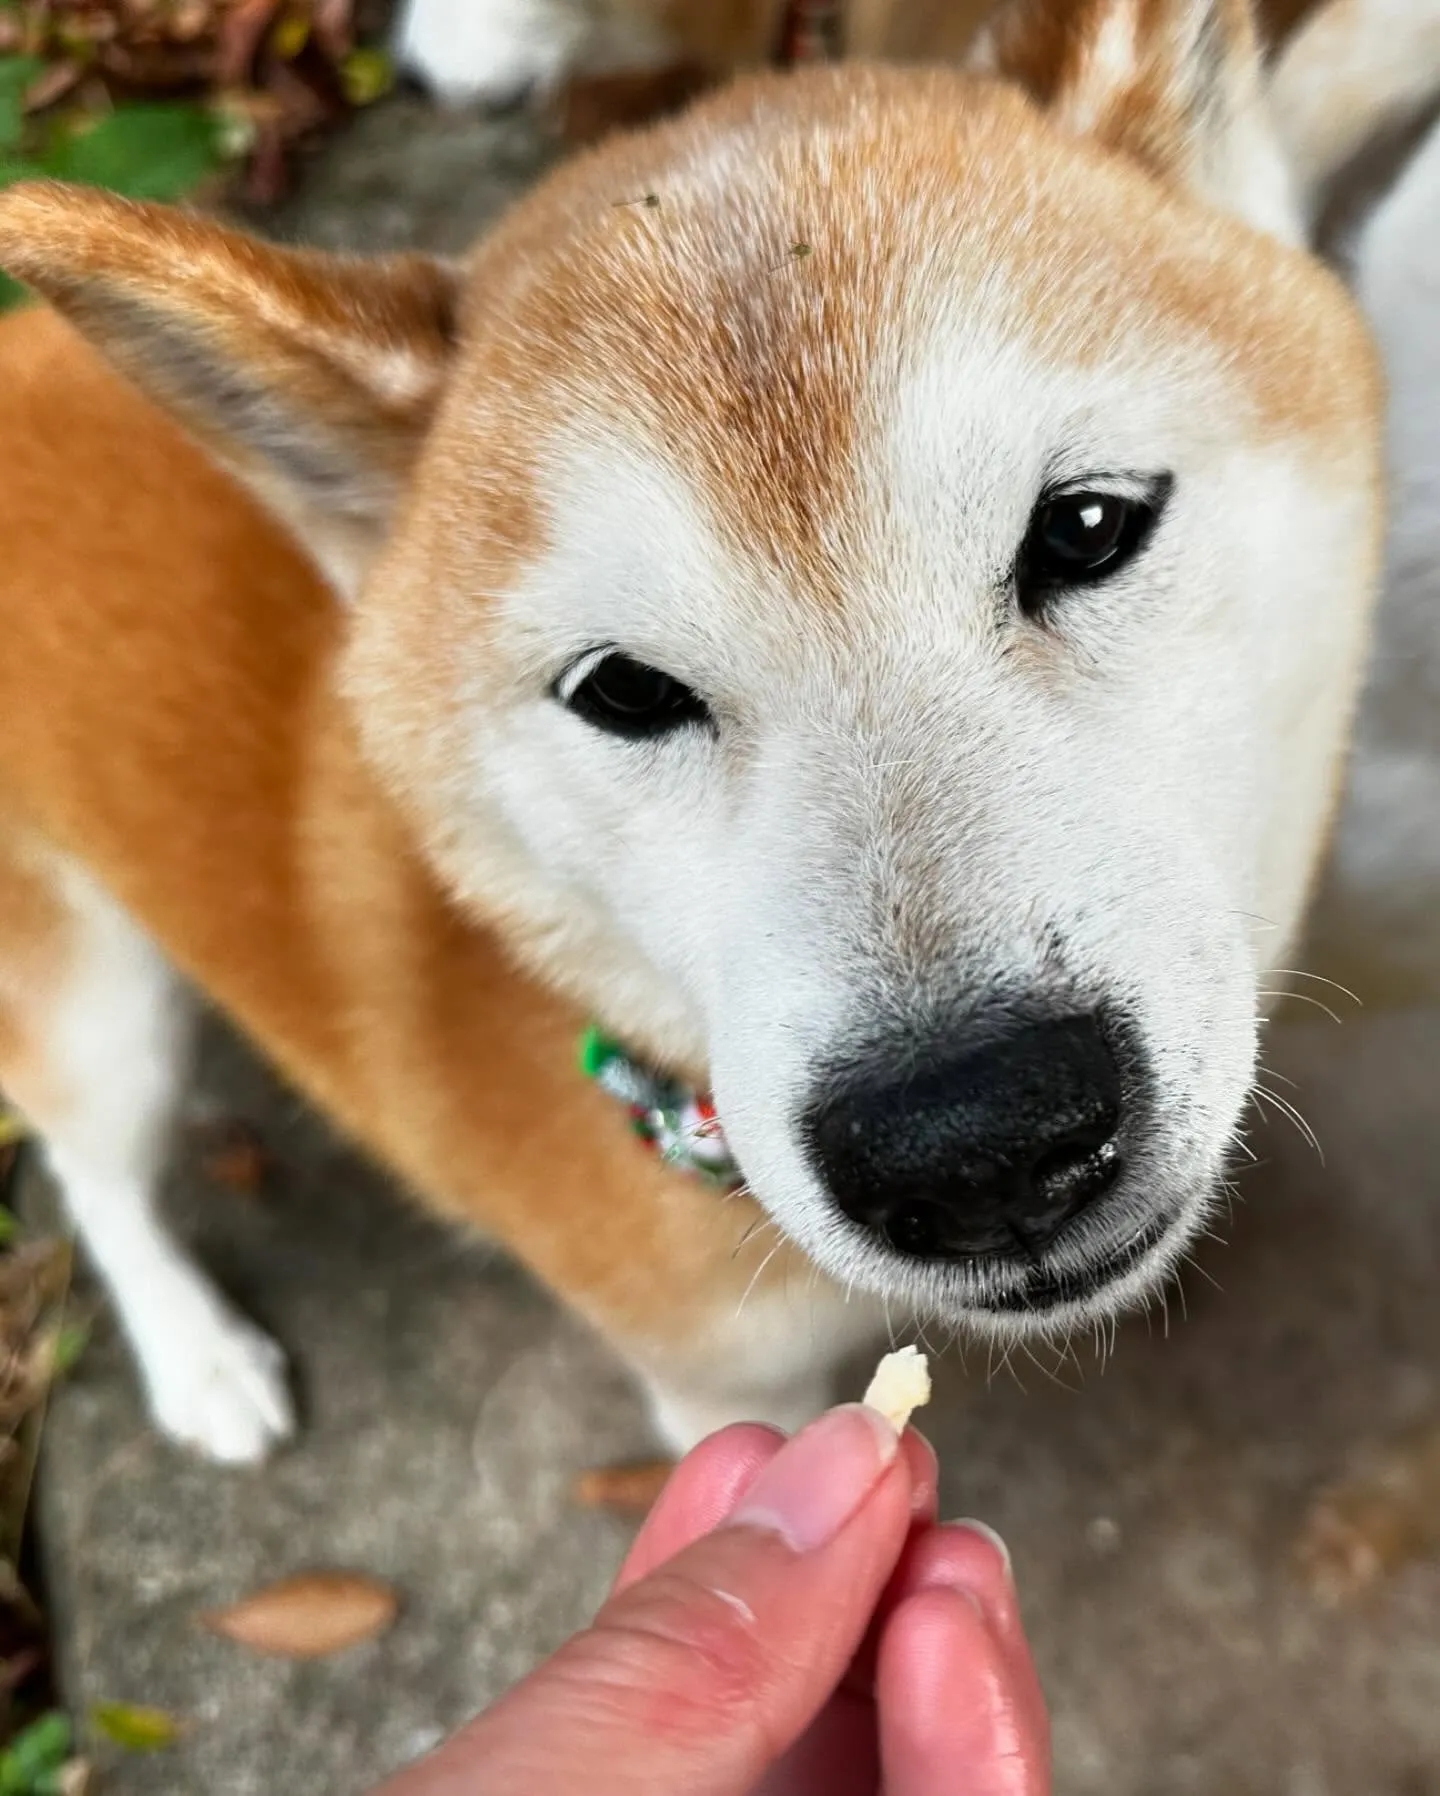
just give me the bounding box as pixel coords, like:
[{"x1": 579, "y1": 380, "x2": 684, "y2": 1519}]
[{"x1": 375, "y1": 1404, "x2": 1050, "y2": 1796}]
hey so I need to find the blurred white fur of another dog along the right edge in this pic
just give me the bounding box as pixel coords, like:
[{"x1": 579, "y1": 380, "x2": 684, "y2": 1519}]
[{"x1": 1316, "y1": 124, "x2": 1440, "y2": 999}]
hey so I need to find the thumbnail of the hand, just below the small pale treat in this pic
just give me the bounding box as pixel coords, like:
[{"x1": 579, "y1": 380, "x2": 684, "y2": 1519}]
[{"x1": 731, "y1": 1403, "x2": 900, "y2": 1554}]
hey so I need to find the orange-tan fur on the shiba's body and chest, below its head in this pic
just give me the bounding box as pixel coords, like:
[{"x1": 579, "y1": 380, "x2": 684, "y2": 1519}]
[{"x1": 0, "y1": 311, "x2": 800, "y2": 1342}]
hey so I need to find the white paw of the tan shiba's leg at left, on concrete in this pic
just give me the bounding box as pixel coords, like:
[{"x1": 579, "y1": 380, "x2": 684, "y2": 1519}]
[{"x1": 144, "y1": 1300, "x2": 294, "y2": 1466}]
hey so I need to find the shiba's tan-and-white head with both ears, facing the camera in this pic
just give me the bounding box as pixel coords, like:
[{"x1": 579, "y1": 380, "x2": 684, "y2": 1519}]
[{"x1": 0, "y1": 0, "x2": 1377, "y2": 1327}]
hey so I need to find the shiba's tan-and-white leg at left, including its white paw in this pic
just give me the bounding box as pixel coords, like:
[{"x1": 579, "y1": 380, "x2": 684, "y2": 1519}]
[{"x1": 0, "y1": 842, "x2": 294, "y2": 1464}]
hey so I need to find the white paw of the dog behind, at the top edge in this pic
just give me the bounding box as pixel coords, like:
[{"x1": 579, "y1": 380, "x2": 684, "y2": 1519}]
[{"x1": 395, "y1": 0, "x2": 591, "y2": 106}]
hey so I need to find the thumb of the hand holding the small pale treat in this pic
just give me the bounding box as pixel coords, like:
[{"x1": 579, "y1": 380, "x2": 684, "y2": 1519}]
[{"x1": 379, "y1": 1404, "x2": 912, "y2": 1796}]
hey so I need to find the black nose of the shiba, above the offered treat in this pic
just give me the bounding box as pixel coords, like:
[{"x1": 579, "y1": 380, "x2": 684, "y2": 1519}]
[{"x1": 804, "y1": 1017, "x2": 1122, "y2": 1259}]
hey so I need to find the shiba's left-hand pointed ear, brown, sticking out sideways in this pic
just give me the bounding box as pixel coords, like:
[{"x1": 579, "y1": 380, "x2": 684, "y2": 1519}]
[{"x1": 0, "y1": 183, "x2": 458, "y2": 587}]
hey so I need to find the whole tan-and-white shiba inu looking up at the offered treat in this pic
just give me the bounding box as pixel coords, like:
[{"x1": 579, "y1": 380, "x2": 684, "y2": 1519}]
[{"x1": 0, "y1": 0, "x2": 1414, "y2": 1460}]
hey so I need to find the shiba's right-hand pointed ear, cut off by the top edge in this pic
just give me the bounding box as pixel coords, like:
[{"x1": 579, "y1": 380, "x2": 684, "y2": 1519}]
[{"x1": 970, "y1": 0, "x2": 1300, "y2": 241}]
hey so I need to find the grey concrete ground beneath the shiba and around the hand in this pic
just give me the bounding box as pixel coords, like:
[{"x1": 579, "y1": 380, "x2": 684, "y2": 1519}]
[{"x1": 25, "y1": 94, "x2": 1440, "y2": 1796}]
